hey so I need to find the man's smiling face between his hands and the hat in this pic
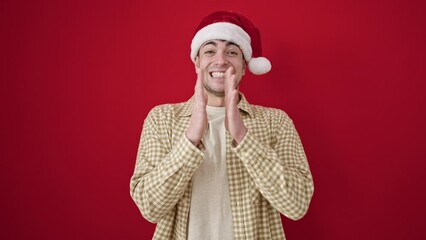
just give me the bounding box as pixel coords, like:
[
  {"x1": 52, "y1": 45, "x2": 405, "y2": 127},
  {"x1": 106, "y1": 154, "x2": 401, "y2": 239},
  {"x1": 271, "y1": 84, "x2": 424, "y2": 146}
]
[{"x1": 195, "y1": 40, "x2": 246, "y2": 96}]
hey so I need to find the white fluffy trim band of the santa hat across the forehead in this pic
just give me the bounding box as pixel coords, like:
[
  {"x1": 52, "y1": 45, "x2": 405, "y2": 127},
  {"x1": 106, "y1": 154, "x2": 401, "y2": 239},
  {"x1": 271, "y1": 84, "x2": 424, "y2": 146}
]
[{"x1": 191, "y1": 22, "x2": 252, "y2": 62}]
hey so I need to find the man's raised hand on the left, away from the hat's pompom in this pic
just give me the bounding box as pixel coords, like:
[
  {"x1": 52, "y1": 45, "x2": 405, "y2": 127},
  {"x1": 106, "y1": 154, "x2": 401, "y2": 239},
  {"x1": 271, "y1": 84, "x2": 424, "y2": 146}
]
[{"x1": 185, "y1": 68, "x2": 208, "y2": 147}]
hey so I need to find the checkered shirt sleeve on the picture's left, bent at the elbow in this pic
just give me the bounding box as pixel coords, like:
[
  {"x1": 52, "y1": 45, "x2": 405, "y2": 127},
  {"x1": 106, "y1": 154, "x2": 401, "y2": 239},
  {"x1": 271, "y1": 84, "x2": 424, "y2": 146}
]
[{"x1": 130, "y1": 107, "x2": 203, "y2": 222}]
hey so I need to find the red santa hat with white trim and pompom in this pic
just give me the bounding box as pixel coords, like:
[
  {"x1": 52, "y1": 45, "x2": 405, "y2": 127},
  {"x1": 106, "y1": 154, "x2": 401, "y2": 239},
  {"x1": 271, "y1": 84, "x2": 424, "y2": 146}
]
[{"x1": 191, "y1": 11, "x2": 271, "y2": 75}]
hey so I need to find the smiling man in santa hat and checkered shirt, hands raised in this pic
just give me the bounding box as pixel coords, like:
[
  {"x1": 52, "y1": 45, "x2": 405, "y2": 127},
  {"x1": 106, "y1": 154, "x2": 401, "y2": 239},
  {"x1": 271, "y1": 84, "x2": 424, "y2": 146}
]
[{"x1": 131, "y1": 11, "x2": 314, "y2": 240}]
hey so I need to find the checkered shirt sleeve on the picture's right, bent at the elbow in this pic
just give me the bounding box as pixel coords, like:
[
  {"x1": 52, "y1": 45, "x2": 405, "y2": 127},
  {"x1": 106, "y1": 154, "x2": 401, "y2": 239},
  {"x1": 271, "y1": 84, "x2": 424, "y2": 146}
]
[{"x1": 233, "y1": 110, "x2": 314, "y2": 220}]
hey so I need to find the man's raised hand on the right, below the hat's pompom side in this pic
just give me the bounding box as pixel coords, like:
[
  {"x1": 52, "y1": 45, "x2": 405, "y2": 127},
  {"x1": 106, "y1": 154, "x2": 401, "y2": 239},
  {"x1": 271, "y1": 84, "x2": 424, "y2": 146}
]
[{"x1": 225, "y1": 67, "x2": 247, "y2": 143}]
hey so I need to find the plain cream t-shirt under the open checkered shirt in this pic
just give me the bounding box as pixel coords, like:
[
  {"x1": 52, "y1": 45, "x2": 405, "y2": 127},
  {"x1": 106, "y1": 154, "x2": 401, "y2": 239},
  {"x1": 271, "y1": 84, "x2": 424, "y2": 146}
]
[{"x1": 188, "y1": 106, "x2": 234, "y2": 240}]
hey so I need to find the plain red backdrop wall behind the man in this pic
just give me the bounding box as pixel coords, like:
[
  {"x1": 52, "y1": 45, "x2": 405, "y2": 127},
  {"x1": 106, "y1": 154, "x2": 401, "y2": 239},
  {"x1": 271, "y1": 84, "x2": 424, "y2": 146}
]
[{"x1": 0, "y1": 0, "x2": 426, "y2": 240}]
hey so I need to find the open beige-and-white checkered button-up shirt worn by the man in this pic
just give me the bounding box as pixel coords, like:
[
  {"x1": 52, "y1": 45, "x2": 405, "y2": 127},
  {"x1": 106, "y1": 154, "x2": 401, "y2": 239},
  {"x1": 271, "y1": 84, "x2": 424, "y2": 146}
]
[{"x1": 130, "y1": 95, "x2": 314, "y2": 240}]
